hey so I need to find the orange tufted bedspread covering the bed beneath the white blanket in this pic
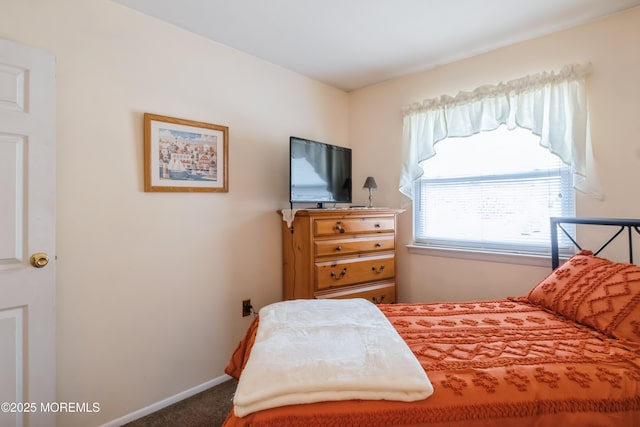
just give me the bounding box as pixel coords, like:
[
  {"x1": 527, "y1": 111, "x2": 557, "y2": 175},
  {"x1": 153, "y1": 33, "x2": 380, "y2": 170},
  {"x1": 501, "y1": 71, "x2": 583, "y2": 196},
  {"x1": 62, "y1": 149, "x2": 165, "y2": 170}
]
[{"x1": 225, "y1": 299, "x2": 640, "y2": 427}]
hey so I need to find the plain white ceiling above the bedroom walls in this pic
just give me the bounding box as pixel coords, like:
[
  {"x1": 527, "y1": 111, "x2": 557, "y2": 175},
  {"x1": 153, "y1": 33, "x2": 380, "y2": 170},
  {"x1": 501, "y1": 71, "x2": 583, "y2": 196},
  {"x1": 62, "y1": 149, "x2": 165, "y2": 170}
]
[{"x1": 113, "y1": 0, "x2": 640, "y2": 91}]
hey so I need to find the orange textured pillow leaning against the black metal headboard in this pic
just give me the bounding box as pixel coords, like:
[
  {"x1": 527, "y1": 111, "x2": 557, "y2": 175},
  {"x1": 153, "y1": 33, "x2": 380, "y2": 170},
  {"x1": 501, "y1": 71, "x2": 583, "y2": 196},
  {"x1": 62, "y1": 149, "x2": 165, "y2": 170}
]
[{"x1": 527, "y1": 251, "x2": 640, "y2": 342}]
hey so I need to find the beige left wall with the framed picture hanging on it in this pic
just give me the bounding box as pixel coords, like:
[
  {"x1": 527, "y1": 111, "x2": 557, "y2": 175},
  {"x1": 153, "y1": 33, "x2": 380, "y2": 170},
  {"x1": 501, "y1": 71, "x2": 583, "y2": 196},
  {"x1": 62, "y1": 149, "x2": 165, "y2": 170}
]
[{"x1": 0, "y1": 0, "x2": 349, "y2": 427}]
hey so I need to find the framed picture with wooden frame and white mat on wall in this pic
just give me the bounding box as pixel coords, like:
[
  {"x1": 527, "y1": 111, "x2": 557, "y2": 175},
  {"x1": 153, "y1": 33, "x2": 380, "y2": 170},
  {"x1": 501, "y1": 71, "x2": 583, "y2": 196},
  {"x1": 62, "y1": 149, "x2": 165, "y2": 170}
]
[{"x1": 144, "y1": 113, "x2": 229, "y2": 193}]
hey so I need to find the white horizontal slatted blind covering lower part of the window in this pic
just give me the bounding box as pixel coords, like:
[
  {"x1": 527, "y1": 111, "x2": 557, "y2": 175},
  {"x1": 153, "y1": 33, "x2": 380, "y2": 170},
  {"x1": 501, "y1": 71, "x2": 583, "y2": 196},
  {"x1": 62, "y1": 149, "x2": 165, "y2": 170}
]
[{"x1": 415, "y1": 167, "x2": 573, "y2": 253}]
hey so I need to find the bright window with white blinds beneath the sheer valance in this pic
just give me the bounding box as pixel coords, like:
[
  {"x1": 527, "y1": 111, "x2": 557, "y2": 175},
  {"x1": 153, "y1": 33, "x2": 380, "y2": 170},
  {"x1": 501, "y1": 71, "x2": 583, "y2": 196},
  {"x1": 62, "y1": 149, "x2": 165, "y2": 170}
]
[{"x1": 414, "y1": 126, "x2": 575, "y2": 255}]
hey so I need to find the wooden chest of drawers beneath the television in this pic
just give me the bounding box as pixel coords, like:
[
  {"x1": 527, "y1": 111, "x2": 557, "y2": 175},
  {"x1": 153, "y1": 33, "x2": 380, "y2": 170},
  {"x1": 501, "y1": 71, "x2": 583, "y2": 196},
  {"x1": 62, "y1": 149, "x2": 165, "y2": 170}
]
[{"x1": 282, "y1": 208, "x2": 403, "y2": 304}]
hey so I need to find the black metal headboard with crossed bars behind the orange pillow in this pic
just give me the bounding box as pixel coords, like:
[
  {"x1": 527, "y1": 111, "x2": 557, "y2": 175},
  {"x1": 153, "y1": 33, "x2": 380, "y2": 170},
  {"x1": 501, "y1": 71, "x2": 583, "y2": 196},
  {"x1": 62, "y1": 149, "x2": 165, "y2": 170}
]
[{"x1": 551, "y1": 217, "x2": 640, "y2": 270}]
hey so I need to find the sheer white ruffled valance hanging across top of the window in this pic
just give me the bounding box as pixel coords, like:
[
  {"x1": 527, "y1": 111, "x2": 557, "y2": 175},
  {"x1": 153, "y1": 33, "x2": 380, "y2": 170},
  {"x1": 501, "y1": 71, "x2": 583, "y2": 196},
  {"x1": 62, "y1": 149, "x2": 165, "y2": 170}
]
[{"x1": 400, "y1": 64, "x2": 602, "y2": 198}]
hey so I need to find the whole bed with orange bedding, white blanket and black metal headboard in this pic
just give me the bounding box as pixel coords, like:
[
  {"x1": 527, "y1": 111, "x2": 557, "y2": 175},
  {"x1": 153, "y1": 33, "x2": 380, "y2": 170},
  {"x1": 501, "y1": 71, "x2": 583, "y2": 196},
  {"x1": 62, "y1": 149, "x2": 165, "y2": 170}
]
[{"x1": 224, "y1": 218, "x2": 640, "y2": 427}]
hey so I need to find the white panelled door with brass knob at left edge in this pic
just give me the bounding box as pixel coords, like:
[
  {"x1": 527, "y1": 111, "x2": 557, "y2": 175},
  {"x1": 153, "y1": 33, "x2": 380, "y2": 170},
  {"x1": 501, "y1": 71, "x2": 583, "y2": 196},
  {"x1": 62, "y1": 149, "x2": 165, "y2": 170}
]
[{"x1": 0, "y1": 39, "x2": 56, "y2": 426}]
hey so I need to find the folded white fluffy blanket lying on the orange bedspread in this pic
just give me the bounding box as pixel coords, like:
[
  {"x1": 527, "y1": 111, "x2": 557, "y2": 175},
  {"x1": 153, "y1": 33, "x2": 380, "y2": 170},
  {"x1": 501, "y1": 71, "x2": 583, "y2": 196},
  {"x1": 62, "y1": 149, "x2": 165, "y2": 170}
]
[{"x1": 234, "y1": 299, "x2": 433, "y2": 417}]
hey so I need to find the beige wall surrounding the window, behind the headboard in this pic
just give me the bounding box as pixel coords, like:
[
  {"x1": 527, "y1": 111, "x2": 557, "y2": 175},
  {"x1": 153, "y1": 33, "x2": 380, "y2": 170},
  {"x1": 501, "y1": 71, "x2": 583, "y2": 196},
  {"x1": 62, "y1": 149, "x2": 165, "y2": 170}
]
[{"x1": 349, "y1": 8, "x2": 640, "y2": 302}]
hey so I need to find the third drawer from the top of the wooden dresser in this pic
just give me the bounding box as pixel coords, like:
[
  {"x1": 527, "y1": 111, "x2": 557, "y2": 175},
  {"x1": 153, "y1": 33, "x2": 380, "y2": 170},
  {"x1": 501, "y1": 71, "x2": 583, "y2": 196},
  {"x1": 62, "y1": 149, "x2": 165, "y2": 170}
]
[{"x1": 315, "y1": 254, "x2": 395, "y2": 291}]
